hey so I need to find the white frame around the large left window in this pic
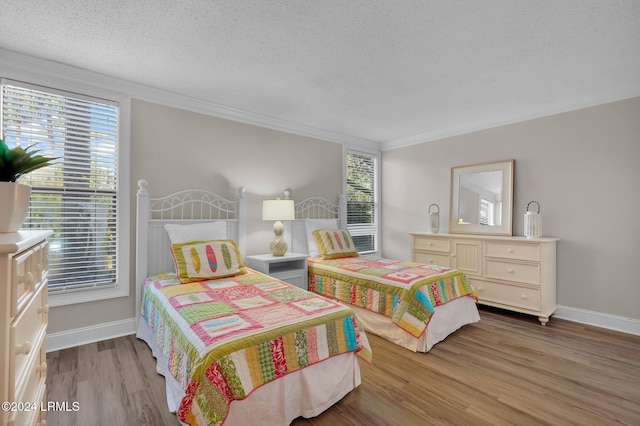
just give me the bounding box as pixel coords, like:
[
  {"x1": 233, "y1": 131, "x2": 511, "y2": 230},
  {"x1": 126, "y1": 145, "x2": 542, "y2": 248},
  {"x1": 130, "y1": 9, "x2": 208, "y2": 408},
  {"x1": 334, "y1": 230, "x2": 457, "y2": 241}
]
[{"x1": 0, "y1": 73, "x2": 131, "y2": 307}]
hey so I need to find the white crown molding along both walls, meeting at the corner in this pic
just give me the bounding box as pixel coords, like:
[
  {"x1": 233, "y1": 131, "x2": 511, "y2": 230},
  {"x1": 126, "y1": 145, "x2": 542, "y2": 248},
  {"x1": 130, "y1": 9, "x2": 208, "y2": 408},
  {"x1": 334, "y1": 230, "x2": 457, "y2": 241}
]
[{"x1": 6, "y1": 49, "x2": 640, "y2": 152}]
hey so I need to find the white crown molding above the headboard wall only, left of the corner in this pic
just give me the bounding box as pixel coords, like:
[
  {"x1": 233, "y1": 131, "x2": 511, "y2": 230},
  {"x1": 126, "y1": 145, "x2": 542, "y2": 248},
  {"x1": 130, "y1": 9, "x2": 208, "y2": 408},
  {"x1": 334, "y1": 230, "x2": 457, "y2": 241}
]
[{"x1": 0, "y1": 49, "x2": 380, "y2": 151}]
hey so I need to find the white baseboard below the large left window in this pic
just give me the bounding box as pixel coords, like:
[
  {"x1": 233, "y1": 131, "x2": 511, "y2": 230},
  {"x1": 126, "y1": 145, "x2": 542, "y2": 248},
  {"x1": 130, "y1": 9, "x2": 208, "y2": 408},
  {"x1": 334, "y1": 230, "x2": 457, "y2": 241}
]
[{"x1": 47, "y1": 318, "x2": 137, "y2": 352}]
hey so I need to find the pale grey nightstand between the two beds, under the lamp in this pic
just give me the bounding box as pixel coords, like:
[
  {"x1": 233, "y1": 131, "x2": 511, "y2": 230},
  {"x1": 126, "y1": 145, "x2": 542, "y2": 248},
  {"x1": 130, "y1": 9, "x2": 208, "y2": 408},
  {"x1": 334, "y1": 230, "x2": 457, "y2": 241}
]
[{"x1": 245, "y1": 253, "x2": 309, "y2": 290}]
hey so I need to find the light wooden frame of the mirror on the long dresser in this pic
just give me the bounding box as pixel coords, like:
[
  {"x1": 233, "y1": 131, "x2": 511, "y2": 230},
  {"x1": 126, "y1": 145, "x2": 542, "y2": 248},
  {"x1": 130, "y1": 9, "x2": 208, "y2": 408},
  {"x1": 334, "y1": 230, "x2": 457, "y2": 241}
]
[{"x1": 449, "y1": 160, "x2": 515, "y2": 235}]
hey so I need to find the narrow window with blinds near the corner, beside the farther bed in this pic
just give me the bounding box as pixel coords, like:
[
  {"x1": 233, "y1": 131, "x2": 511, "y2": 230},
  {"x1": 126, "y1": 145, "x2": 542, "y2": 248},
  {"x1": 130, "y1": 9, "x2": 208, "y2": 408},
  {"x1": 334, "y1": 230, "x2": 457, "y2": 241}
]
[{"x1": 346, "y1": 150, "x2": 379, "y2": 253}]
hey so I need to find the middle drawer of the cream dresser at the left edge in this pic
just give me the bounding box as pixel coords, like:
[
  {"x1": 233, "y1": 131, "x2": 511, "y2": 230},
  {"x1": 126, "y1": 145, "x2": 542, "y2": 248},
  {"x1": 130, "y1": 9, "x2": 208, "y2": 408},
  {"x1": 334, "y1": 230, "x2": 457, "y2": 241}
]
[{"x1": 9, "y1": 286, "x2": 48, "y2": 390}]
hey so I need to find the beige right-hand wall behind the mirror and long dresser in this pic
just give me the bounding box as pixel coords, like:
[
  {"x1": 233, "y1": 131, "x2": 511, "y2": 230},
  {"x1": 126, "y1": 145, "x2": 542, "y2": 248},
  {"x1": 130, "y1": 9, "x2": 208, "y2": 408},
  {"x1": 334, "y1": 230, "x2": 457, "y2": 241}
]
[{"x1": 382, "y1": 98, "x2": 640, "y2": 319}]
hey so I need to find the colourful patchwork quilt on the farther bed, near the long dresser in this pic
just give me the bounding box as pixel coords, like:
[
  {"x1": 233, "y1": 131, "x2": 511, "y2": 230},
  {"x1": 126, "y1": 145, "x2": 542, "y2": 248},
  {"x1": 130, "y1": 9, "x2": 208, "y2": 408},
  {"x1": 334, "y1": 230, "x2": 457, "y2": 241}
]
[{"x1": 309, "y1": 256, "x2": 477, "y2": 337}]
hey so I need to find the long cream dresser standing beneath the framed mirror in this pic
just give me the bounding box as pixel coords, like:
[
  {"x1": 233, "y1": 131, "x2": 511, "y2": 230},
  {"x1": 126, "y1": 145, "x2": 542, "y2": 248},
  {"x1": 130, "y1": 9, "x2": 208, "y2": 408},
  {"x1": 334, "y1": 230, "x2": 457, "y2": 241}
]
[{"x1": 411, "y1": 233, "x2": 558, "y2": 325}]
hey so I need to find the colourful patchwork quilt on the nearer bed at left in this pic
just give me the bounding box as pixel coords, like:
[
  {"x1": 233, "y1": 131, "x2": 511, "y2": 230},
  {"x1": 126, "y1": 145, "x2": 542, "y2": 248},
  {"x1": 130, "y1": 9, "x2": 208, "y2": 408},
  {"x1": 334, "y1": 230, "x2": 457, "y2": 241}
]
[{"x1": 141, "y1": 268, "x2": 371, "y2": 425}]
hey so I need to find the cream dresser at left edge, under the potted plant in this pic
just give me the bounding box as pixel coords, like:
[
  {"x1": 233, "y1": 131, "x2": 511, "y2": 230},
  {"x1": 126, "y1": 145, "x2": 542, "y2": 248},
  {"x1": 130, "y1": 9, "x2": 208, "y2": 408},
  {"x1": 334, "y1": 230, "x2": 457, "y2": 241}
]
[{"x1": 0, "y1": 230, "x2": 52, "y2": 426}]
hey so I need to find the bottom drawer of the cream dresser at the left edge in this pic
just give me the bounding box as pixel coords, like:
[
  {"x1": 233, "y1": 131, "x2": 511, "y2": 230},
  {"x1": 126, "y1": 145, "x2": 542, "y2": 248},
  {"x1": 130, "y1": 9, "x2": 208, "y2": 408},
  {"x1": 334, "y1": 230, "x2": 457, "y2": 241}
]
[{"x1": 7, "y1": 339, "x2": 47, "y2": 426}]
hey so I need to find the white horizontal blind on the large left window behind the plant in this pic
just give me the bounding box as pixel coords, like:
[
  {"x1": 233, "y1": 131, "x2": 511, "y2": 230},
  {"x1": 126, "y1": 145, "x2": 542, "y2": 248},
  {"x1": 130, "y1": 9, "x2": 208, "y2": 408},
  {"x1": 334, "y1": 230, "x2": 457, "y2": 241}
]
[{"x1": 1, "y1": 80, "x2": 119, "y2": 292}]
